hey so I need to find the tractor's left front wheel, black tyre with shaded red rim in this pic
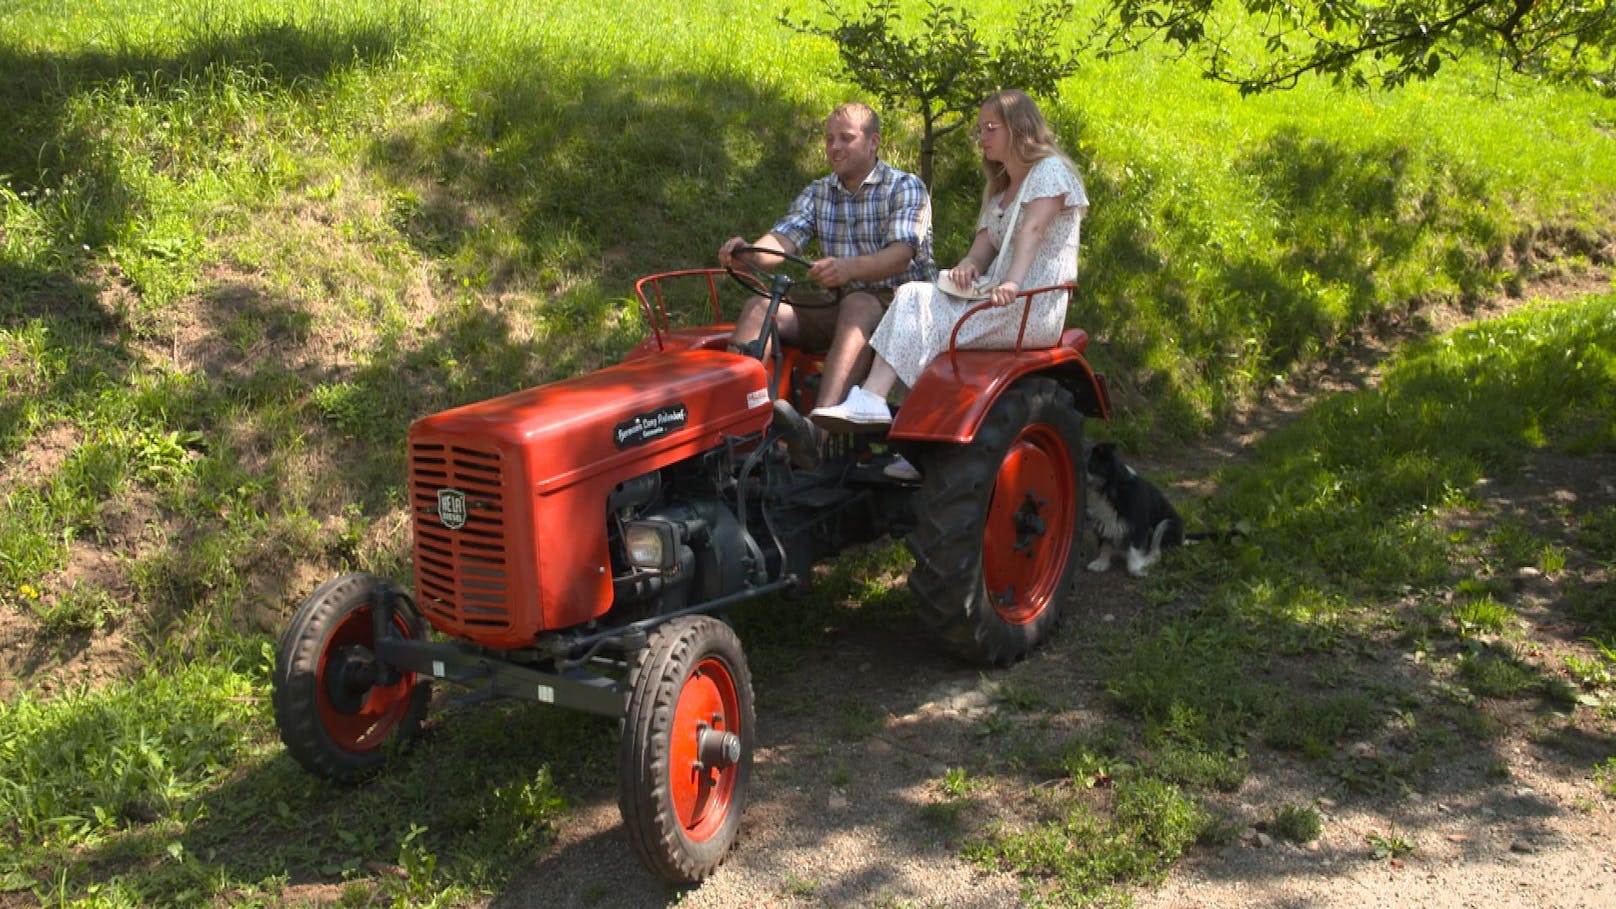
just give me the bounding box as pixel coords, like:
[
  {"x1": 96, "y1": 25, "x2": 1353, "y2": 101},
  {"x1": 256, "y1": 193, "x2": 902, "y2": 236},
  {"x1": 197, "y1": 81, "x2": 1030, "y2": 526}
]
[{"x1": 273, "y1": 573, "x2": 431, "y2": 781}]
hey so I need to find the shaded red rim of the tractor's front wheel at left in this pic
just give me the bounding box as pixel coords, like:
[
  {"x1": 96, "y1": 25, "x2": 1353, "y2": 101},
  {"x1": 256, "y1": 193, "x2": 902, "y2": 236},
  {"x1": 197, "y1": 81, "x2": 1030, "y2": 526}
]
[{"x1": 315, "y1": 607, "x2": 415, "y2": 754}]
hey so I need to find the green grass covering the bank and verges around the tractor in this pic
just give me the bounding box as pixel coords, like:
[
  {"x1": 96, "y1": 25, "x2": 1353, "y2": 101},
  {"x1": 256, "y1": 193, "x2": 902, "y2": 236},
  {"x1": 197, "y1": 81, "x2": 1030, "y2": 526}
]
[{"x1": 0, "y1": 0, "x2": 1616, "y2": 906}]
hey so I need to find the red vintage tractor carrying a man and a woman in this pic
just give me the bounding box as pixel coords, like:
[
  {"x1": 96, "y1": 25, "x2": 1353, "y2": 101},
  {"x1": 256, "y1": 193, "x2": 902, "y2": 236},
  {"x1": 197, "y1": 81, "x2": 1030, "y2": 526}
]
[{"x1": 275, "y1": 247, "x2": 1109, "y2": 883}]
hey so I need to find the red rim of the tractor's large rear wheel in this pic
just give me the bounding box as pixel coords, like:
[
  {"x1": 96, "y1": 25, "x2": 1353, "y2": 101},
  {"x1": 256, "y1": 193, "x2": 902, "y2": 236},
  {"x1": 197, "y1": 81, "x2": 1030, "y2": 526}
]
[{"x1": 983, "y1": 424, "x2": 1078, "y2": 624}]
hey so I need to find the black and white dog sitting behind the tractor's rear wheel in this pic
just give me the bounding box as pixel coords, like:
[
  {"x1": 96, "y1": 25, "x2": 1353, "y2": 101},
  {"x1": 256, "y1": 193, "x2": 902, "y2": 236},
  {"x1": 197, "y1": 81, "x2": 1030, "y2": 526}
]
[{"x1": 1086, "y1": 442, "x2": 1185, "y2": 577}]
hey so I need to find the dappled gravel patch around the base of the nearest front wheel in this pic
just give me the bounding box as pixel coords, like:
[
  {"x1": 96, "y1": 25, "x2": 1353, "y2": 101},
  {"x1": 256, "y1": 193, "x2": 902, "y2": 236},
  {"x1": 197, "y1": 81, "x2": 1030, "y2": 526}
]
[{"x1": 493, "y1": 621, "x2": 1052, "y2": 909}]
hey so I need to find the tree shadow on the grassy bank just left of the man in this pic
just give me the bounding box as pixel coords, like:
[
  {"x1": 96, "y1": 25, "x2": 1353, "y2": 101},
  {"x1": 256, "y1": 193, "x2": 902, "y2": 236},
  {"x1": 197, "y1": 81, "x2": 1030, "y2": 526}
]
[{"x1": 372, "y1": 53, "x2": 814, "y2": 310}]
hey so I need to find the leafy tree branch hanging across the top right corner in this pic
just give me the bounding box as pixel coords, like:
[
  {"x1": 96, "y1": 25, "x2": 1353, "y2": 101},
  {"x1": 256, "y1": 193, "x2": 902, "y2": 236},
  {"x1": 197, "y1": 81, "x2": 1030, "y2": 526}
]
[{"x1": 1096, "y1": 0, "x2": 1616, "y2": 94}]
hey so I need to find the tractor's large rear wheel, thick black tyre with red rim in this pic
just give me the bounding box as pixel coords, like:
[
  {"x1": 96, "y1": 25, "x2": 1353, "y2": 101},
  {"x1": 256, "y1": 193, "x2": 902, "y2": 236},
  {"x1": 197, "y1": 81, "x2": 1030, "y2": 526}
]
[{"x1": 905, "y1": 377, "x2": 1084, "y2": 666}]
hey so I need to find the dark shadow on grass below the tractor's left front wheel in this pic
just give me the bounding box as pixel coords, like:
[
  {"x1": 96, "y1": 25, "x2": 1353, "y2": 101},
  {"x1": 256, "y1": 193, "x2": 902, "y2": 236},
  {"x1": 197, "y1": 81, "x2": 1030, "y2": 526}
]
[{"x1": 94, "y1": 692, "x2": 629, "y2": 903}]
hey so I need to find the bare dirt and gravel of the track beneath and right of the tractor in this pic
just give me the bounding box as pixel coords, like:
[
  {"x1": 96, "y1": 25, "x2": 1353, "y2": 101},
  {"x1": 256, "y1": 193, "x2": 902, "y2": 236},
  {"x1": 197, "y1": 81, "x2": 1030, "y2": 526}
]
[{"x1": 490, "y1": 278, "x2": 1616, "y2": 909}]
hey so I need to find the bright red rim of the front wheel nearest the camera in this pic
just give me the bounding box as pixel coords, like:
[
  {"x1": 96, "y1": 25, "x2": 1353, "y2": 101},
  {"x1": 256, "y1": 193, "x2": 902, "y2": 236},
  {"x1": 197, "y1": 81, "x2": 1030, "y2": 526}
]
[{"x1": 667, "y1": 657, "x2": 743, "y2": 843}]
